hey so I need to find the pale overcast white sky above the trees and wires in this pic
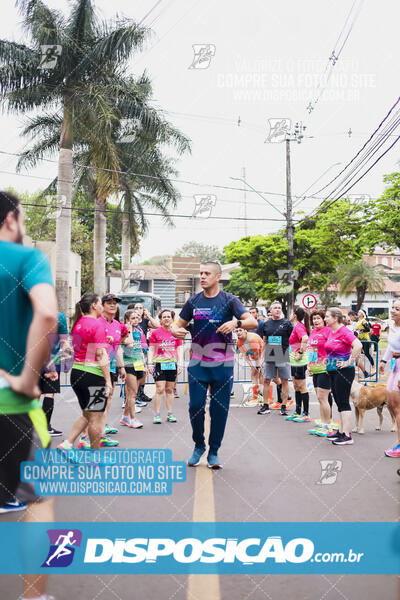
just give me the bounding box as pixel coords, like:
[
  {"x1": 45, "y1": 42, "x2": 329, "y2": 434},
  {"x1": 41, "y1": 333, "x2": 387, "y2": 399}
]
[{"x1": 0, "y1": 0, "x2": 400, "y2": 262}]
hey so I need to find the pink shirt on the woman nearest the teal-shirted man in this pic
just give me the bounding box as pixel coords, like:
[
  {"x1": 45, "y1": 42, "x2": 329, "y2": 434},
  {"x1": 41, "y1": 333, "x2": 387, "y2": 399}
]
[{"x1": 72, "y1": 315, "x2": 107, "y2": 372}]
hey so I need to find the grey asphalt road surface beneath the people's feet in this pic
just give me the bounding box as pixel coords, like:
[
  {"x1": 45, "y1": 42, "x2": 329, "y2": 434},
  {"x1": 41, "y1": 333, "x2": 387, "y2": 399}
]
[{"x1": 0, "y1": 385, "x2": 400, "y2": 600}]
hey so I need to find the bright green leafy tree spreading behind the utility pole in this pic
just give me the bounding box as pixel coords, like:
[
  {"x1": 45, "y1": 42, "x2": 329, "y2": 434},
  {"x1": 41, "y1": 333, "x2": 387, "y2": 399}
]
[{"x1": 224, "y1": 200, "x2": 365, "y2": 310}]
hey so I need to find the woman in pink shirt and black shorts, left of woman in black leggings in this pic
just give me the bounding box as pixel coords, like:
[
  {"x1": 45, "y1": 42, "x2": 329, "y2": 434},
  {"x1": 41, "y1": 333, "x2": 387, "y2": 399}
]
[{"x1": 308, "y1": 308, "x2": 332, "y2": 437}]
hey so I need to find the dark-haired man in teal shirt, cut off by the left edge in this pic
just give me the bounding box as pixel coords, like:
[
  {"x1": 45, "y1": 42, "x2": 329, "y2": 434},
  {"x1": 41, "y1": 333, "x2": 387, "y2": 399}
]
[{"x1": 0, "y1": 192, "x2": 57, "y2": 598}]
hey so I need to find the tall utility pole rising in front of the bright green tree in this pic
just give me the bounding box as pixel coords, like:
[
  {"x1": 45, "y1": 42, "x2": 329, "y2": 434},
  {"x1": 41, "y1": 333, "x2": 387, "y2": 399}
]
[{"x1": 285, "y1": 122, "x2": 306, "y2": 317}]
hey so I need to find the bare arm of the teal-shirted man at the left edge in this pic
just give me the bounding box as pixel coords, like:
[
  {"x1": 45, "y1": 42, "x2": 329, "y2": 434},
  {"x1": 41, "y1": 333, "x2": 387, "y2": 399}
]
[{"x1": 0, "y1": 283, "x2": 58, "y2": 398}]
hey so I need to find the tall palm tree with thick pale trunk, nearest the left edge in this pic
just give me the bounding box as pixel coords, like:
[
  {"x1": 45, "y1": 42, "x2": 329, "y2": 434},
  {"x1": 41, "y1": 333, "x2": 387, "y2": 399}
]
[{"x1": 0, "y1": 0, "x2": 147, "y2": 314}]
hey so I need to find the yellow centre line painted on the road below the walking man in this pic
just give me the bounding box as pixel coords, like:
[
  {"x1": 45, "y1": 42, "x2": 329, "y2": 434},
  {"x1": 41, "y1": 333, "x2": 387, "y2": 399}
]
[{"x1": 186, "y1": 411, "x2": 221, "y2": 600}]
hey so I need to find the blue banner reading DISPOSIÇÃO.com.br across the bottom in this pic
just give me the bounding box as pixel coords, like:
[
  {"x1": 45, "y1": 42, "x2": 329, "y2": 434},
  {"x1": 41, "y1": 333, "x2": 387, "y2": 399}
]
[{"x1": 0, "y1": 523, "x2": 400, "y2": 575}]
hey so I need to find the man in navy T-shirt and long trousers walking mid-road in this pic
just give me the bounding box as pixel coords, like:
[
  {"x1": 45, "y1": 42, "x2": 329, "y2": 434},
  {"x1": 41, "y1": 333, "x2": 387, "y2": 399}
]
[{"x1": 171, "y1": 262, "x2": 257, "y2": 469}]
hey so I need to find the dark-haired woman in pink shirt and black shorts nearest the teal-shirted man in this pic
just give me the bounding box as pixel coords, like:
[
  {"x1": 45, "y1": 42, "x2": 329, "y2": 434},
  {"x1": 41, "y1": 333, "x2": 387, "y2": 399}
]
[{"x1": 58, "y1": 293, "x2": 112, "y2": 450}]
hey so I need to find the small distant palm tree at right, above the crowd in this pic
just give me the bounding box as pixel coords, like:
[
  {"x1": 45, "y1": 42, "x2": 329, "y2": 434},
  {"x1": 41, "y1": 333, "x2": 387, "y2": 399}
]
[{"x1": 336, "y1": 259, "x2": 385, "y2": 312}]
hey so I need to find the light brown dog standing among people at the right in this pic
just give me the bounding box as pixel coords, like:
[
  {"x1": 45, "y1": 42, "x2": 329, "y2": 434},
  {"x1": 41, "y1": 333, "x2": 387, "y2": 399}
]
[{"x1": 350, "y1": 381, "x2": 396, "y2": 433}]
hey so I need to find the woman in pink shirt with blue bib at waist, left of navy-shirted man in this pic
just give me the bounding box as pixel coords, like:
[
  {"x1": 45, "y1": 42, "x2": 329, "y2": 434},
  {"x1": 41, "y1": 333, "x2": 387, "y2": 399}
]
[{"x1": 149, "y1": 309, "x2": 183, "y2": 424}]
